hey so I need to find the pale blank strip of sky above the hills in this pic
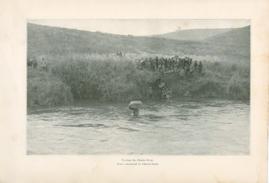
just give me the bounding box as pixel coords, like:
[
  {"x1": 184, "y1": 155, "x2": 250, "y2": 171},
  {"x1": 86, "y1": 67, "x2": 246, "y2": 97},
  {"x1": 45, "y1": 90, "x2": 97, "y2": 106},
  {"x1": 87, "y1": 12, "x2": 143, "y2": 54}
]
[{"x1": 28, "y1": 19, "x2": 250, "y2": 36}]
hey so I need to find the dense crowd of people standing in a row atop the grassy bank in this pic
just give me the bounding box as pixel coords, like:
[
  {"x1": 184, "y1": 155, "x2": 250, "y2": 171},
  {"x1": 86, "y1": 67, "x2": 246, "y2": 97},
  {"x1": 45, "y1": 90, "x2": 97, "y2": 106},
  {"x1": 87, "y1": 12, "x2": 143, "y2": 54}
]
[{"x1": 139, "y1": 56, "x2": 203, "y2": 74}]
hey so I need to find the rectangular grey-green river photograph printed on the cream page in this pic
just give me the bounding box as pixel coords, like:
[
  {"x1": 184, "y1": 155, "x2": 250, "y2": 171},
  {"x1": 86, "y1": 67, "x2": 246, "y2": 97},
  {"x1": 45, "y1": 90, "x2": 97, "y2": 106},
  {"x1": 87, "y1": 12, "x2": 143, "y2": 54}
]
[{"x1": 25, "y1": 19, "x2": 251, "y2": 155}]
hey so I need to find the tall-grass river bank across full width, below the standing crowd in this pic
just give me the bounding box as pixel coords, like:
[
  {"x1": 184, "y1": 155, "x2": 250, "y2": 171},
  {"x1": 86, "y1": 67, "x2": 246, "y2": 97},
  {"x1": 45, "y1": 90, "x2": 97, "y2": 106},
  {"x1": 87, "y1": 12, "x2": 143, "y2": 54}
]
[{"x1": 27, "y1": 56, "x2": 250, "y2": 107}]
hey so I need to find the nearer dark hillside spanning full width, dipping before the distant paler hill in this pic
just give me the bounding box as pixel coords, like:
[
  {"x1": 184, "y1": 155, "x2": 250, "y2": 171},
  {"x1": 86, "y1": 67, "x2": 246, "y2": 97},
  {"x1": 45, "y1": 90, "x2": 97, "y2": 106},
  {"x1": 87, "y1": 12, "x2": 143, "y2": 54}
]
[{"x1": 27, "y1": 23, "x2": 250, "y2": 62}]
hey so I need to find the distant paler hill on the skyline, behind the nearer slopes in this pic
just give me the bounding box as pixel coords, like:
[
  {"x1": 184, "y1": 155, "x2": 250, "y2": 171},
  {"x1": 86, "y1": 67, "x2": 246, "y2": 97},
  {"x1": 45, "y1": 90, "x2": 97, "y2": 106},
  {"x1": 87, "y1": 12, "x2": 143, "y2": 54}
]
[{"x1": 153, "y1": 29, "x2": 231, "y2": 41}]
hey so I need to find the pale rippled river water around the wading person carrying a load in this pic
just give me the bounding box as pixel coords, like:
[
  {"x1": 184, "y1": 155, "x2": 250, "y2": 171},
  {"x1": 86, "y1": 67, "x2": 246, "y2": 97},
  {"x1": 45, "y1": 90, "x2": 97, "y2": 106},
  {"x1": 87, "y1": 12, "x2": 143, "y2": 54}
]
[{"x1": 27, "y1": 100, "x2": 250, "y2": 155}]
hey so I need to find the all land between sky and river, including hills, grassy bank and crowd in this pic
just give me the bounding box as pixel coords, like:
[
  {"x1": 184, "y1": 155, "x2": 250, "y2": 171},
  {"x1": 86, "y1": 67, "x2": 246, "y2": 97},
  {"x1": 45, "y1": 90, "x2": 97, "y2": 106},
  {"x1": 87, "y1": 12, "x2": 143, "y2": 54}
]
[{"x1": 27, "y1": 24, "x2": 250, "y2": 107}]
